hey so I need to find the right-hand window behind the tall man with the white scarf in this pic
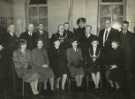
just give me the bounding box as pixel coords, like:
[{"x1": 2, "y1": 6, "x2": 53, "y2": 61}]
[{"x1": 98, "y1": 0, "x2": 126, "y2": 31}]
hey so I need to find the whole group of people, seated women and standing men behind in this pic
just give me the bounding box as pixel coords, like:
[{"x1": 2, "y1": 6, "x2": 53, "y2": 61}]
[{"x1": 0, "y1": 18, "x2": 135, "y2": 95}]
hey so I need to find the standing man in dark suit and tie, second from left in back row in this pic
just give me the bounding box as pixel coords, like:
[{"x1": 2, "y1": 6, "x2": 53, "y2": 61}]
[{"x1": 20, "y1": 24, "x2": 38, "y2": 50}]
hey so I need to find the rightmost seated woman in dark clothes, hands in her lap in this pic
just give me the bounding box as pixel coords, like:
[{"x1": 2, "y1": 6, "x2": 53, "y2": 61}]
[{"x1": 107, "y1": 42, "x2": 124, "y2": 89}]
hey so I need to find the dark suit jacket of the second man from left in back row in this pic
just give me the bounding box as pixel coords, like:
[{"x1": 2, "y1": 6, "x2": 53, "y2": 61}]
[{"x1": 20, "y1": 32, "x2": 38, "y2": 50}]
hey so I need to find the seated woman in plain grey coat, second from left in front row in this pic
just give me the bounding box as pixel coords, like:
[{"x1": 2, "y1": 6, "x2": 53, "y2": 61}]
[{"x1": 32, "y1": 40, "x2": 54, "y2": 90}]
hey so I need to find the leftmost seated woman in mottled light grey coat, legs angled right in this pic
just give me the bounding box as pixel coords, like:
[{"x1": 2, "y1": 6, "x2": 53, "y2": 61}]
[{"x1": 13, "y1": 39, "x2": 39, "y2": 95}]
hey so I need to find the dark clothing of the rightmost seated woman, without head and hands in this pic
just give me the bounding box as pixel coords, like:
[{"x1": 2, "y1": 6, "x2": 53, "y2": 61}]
[{"x1": 105, "y1": 47, "x2": 125, "y2": 86}]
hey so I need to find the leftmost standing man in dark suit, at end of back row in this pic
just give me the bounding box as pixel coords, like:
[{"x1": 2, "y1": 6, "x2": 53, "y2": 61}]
[{"x1": 2, "y1": 24, "x2": 18, "y2": 94}]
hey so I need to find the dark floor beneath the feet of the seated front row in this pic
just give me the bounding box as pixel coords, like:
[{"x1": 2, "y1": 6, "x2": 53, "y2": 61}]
[{"x1": 0, "y1": 79, "x2": 135, "y2": 99}]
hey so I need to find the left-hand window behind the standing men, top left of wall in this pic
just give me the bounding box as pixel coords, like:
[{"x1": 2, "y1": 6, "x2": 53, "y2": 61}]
[{"x1": 26, "y1": 0, "x2": 48, "y2": 30}]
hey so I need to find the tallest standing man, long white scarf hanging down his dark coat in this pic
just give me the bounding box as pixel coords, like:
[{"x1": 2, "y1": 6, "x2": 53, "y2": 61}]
[{"x1": 98, "y1": 19, "x2": 120, "y2": 86}]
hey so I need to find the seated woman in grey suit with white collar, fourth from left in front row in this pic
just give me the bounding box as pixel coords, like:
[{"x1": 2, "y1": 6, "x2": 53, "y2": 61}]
[{"x1": 67, "y1": 39, "x2": 84, "y2": 87}]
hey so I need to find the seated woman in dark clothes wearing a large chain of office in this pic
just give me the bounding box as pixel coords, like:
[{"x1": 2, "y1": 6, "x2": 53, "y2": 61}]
[{"x1": 87, "y1": 39, "x2": 100, "y2": 88}]
